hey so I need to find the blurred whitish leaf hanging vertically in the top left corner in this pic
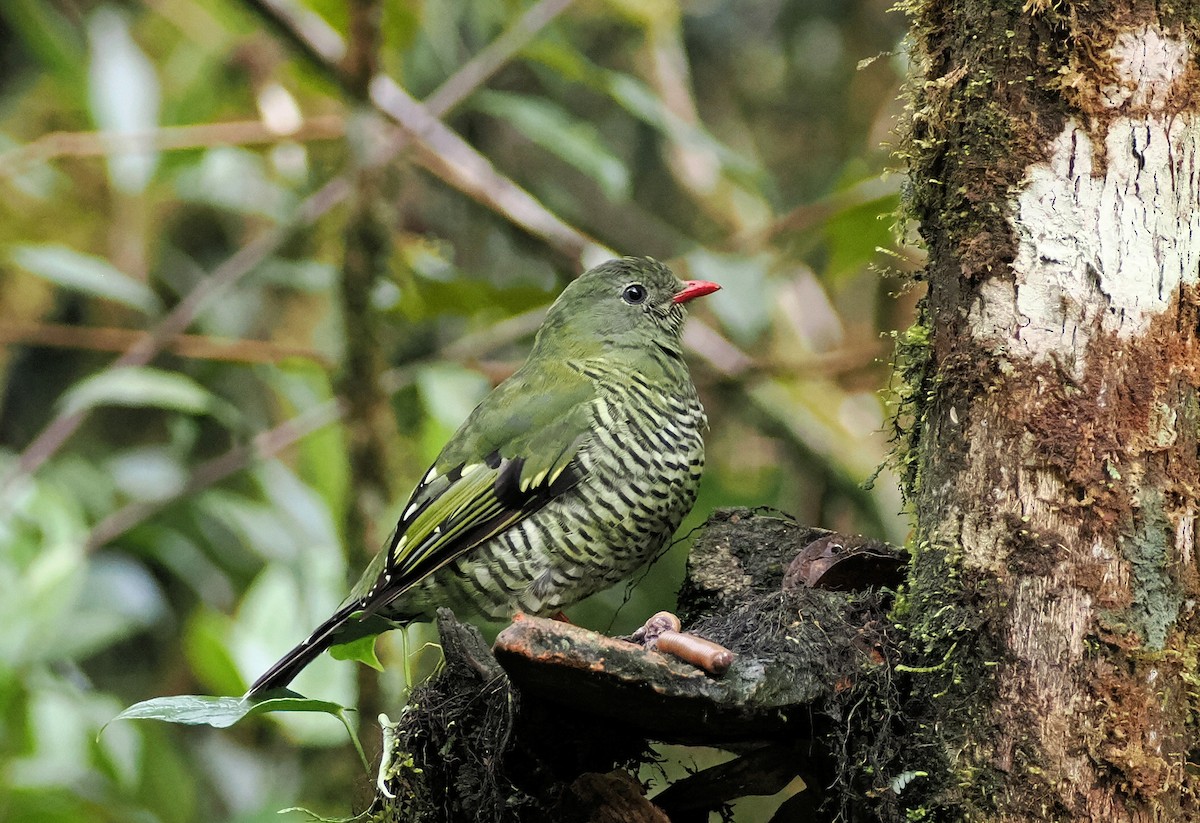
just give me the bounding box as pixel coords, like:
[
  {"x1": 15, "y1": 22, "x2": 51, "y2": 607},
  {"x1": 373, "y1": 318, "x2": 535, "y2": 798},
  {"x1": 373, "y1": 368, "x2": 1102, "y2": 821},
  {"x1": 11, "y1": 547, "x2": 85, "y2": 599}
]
[{"x1": 88, "y1": 6, "x2": 160, "y2": 194}]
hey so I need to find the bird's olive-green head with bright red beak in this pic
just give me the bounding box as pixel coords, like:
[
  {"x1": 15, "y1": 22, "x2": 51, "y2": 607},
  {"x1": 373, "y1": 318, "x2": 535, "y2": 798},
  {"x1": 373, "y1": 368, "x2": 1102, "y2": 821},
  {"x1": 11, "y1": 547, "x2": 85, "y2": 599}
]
[{"x1": 536, "y1": 257, "x2": 721, "y2": 354}]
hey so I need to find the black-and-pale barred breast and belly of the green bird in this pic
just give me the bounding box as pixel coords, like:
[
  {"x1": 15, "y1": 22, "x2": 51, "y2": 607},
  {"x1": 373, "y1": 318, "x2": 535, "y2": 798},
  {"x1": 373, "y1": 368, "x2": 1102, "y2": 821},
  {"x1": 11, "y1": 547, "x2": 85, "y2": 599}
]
[{"x1": 398, "y1": 354, "x2": 707, "y2": 620}]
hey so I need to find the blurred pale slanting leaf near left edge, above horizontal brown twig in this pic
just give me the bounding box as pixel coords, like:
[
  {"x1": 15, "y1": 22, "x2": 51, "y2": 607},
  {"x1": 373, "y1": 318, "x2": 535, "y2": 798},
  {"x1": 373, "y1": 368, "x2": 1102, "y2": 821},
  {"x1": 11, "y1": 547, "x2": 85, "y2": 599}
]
[{"x1": 8, "y1": 244, "x2": 162, "y2": 314}]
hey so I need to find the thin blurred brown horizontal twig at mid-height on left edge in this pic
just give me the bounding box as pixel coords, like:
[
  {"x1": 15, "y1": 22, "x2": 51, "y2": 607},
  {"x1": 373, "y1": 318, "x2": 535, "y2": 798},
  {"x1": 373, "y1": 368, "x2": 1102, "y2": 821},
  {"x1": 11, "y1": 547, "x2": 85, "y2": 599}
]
[{"x1": 0, "y1": 323, "x2": 332, "y2": 368}]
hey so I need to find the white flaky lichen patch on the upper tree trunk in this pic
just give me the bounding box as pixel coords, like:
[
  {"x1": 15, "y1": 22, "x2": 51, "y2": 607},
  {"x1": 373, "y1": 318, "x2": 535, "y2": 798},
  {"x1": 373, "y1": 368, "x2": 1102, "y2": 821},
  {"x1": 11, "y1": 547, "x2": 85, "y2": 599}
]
[{"x1": 970, "y1": 28, "x2": 1200, "y2": 379}]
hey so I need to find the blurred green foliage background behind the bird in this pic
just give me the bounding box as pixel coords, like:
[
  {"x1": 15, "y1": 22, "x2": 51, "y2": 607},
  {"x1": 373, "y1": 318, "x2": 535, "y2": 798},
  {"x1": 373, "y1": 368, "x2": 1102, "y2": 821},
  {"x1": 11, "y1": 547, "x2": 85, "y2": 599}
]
[{"x1": 0, "y1": 0, "x2": 919, "y2": 823}]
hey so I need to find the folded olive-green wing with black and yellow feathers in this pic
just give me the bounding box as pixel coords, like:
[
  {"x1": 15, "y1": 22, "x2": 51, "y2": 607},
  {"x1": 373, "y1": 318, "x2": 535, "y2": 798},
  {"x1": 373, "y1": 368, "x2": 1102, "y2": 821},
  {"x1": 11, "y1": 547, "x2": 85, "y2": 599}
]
[{"x1": 348, "y1": 364, "x2": 595, "y2": 618}]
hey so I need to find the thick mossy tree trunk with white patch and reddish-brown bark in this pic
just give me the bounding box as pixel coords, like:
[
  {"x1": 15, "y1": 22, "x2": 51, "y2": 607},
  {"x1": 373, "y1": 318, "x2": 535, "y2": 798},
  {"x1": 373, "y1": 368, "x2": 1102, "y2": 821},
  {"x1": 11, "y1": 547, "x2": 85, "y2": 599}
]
[{"x1": 896, "y1": 0, "x2": 1200, "y2": 822}]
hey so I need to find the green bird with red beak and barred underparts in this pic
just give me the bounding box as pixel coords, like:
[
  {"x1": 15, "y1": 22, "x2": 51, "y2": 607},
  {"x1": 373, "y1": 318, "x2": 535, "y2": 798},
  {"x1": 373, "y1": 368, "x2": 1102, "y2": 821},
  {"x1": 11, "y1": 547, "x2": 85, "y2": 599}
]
[{"x1": 247, "y1": 257, "x2": 720, "y2": 696}]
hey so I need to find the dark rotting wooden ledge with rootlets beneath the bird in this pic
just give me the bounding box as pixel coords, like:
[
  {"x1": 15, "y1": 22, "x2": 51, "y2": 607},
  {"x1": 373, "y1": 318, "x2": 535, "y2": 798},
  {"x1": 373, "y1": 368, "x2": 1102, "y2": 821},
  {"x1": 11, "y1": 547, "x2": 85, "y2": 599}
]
[{"x1": 374, "y1": 510, "x2": 905, "y2": 823}]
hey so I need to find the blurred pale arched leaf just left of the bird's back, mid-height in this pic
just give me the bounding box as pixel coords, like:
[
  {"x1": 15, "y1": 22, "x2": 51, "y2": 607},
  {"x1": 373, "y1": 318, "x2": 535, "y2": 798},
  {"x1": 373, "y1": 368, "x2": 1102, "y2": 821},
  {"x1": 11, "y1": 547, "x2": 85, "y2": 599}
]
[{"x1": 59, "y1": 366, "x2": 218, "y2": 414}]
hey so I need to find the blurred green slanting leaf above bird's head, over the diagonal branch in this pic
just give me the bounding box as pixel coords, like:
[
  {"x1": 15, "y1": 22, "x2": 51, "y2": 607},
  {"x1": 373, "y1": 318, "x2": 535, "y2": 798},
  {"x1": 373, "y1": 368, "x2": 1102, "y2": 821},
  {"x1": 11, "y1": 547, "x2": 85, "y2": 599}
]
[{"x1": 472, "y1": 91, "x2": 631, "y2": 200}]
